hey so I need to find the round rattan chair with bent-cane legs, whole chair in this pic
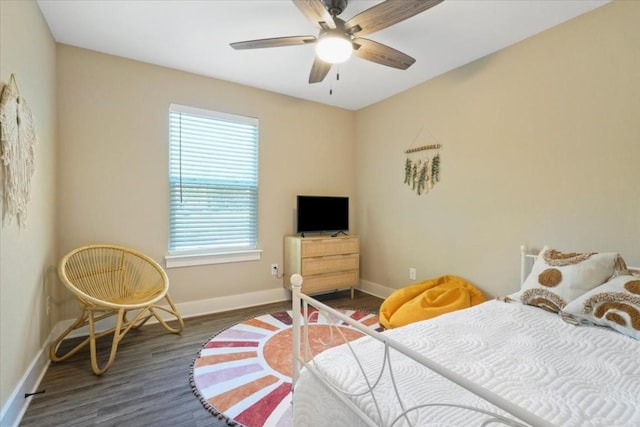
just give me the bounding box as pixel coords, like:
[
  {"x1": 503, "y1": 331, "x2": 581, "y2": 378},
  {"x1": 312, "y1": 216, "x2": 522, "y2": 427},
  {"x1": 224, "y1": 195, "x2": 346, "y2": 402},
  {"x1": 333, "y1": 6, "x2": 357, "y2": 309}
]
[{"x1": 49, "y1": 245, "x2": 184, "y2": 375}]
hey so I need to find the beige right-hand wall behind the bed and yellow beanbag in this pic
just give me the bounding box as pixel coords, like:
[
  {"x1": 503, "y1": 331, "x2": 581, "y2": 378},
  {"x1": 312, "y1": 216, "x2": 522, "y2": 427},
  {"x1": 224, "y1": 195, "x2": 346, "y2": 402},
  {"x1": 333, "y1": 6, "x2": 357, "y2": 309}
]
[{"x1": 356, "y1": 1, "x2": 640, "y2": 295}]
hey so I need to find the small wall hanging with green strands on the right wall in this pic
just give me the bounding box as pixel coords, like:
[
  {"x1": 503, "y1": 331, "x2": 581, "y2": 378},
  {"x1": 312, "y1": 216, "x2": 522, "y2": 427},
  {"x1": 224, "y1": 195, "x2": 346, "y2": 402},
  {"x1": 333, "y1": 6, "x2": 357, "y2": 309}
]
[{"x1": 404, "y1": 129, "x2": 442, "y2": 196}]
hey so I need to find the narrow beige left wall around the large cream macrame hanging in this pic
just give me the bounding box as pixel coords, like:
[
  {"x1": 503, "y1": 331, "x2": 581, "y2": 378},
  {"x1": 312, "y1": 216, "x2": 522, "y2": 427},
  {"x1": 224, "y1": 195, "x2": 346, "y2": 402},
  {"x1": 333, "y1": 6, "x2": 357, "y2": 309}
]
[{"x1": 0, "y1": 0, "x2": 56, "y2": 408}]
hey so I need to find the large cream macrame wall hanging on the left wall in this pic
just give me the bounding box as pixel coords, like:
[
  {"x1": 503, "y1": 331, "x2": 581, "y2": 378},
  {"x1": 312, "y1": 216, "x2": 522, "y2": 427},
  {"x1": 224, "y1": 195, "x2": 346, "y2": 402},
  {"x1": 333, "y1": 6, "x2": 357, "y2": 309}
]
[{"x1": 0, "y1": 74, "x2": 36, "y2": 227}]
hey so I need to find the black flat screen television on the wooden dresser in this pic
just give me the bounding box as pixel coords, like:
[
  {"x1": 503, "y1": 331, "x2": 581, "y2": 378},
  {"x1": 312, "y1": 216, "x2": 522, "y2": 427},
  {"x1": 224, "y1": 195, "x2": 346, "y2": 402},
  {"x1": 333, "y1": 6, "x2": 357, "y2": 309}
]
[{"x1": 296, "y1": 195, "x2": 349, "y2": 233}]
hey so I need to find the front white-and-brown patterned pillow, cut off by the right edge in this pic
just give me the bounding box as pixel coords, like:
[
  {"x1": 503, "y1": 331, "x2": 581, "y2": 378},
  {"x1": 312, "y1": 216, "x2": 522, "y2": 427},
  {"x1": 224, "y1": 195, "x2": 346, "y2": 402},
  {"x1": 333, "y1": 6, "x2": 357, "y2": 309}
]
[{"x1": 562, "y1": 274, "x2": 640, "y2": 340}]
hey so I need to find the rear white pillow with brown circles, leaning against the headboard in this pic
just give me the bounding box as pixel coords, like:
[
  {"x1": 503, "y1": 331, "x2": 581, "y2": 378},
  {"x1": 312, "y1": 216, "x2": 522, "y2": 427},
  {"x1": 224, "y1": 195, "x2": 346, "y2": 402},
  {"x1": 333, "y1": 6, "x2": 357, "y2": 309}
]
[{"x1": 518, "y1": 246, "x2": 621, "y2": 313}]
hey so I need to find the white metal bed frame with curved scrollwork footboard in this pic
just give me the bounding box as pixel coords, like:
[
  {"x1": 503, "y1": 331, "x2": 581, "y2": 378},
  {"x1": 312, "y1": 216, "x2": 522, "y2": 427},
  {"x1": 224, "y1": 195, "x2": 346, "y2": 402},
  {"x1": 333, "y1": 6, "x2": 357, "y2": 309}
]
[{"x1": 291, "y1": 245, "x2": 553, "y2": 427}]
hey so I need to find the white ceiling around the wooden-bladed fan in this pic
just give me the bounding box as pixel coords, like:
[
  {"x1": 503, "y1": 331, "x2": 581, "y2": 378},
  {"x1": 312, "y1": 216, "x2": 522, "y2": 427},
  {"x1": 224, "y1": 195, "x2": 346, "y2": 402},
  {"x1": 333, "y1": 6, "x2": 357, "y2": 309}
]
[{"x1": 38, "y1": 0, "x2": 609, "y2": 110}]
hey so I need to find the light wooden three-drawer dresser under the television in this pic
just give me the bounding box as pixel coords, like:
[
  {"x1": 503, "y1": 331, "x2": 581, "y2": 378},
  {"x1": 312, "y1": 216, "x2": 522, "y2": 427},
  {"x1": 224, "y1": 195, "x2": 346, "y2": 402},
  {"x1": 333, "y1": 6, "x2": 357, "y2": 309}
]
[{"x1": 284, "y1": 236, "x2": 360, "y2": 298}]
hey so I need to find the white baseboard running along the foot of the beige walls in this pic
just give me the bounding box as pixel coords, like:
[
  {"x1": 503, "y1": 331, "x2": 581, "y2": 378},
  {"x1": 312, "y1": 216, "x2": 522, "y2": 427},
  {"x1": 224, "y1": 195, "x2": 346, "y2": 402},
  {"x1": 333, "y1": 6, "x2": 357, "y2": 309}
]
[{"x1": 0, "y1": 280, "x2": 395, "y2": 427}]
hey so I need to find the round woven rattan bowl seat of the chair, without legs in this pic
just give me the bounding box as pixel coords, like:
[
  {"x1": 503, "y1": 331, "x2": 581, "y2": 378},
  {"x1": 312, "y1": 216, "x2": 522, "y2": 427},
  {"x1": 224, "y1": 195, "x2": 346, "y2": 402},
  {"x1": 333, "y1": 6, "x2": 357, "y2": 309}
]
[{"x1": 58, "y1": 245, "x2": 169, "y2": 309}]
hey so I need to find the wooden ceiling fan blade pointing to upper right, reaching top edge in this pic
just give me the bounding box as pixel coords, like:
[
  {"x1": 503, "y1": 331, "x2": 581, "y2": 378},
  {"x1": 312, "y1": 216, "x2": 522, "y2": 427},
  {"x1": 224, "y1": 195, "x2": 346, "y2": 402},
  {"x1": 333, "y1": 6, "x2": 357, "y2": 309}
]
[{"x1": 345, "y1": 0, "x2": 443, "y2": 36}]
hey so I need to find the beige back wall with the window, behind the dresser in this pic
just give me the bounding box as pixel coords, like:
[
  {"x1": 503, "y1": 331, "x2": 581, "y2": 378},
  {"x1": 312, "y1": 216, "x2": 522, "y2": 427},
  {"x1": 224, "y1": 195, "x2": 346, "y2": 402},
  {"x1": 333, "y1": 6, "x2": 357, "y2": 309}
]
[{"x1": 57, "y1": 45, "x2": 355, "y2": 317}]
